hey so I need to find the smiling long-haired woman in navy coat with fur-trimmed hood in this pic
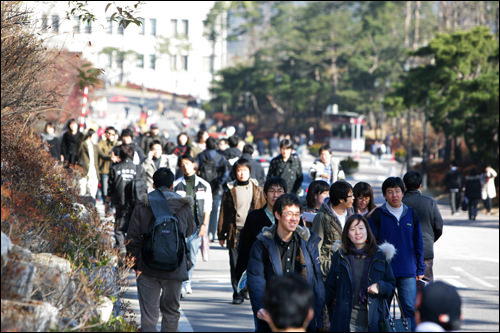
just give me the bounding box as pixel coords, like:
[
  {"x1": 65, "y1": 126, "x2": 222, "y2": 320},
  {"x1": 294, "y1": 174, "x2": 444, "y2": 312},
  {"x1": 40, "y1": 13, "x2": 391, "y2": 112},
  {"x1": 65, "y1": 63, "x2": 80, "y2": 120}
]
[{"x1": 325, "y1": 214, "x2": 396, "y2": 332}]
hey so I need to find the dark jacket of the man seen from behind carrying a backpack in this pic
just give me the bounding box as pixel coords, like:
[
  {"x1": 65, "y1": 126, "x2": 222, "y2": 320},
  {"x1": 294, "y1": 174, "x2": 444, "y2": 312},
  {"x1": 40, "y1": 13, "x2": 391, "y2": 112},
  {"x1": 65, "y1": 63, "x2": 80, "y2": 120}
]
[{"x1": 127, "y1": 190, "x2": 196, "y2": 281}]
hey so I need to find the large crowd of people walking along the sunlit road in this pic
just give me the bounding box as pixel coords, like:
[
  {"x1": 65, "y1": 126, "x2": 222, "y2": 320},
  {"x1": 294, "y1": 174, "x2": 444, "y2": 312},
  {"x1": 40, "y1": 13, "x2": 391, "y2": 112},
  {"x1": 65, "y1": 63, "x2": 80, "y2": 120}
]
[{"x1": 39, "y1": 120, "x2": 488, "y2": 332}]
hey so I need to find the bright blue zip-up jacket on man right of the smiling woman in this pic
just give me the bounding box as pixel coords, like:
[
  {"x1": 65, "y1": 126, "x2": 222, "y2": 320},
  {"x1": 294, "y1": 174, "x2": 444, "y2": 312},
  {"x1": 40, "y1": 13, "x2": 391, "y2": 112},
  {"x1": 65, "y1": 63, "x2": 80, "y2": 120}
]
[{"x1": 368, "y1": 202, "x2": 425, "y2": 278}]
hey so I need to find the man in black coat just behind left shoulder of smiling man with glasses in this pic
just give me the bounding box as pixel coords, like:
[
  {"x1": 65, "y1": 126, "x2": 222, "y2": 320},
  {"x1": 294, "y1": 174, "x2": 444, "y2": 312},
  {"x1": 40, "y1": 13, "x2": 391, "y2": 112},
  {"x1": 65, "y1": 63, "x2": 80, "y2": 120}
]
[{"x1": 236, "y1": 177, "x2": 286, "y2": 296}]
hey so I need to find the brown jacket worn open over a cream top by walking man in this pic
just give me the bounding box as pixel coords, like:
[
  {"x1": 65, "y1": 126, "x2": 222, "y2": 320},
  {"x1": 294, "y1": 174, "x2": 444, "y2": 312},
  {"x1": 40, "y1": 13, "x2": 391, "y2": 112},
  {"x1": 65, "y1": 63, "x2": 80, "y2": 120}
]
[{"x1": 217, "y1": 178, "x2": 266, "y2": 248}]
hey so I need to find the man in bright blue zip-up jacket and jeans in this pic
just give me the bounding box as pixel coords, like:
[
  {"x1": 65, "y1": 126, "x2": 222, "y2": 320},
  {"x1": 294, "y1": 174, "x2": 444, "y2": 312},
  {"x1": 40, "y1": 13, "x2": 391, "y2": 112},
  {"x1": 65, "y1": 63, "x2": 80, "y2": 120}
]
[{"x1": 369, "y1": 177, "x2": 425, "y2": 330}]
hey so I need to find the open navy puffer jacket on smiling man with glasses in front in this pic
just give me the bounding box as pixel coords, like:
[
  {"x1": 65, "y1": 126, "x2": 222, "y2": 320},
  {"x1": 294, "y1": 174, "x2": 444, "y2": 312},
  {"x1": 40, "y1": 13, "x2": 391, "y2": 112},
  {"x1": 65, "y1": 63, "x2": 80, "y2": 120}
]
[{"x1": 247, "y1": 225, "x2": 325, "y2": 332}]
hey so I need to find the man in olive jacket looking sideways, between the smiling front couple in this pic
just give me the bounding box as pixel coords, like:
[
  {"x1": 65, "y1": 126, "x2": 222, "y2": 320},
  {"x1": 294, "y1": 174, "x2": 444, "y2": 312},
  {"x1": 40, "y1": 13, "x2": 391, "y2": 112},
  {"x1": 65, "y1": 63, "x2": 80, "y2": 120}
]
[{"x1": 311, "y1": 180, "x2": 354, "y2": 280}]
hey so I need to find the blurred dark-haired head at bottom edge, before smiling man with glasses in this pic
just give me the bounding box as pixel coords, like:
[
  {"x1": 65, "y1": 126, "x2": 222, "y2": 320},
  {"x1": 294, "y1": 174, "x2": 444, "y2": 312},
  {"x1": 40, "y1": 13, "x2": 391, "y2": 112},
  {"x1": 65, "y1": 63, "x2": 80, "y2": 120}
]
[{"x1": 262, "y1": 273, "x2": 314, "y2": 329}]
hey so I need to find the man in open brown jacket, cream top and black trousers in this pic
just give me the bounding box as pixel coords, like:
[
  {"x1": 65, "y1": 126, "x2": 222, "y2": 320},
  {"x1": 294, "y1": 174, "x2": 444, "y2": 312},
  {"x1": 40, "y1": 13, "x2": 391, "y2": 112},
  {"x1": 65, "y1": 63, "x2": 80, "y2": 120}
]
[{"x1": 218, "y1": 159, "x2": 266, "y2": 304}]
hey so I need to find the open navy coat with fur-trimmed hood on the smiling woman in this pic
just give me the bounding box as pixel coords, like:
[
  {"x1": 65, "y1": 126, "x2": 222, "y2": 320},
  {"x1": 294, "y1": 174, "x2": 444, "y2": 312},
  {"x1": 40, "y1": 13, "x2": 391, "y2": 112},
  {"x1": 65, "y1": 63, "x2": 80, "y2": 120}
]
[{"x1": 325, "y1": 241, "x2": 396, "y2": 332}]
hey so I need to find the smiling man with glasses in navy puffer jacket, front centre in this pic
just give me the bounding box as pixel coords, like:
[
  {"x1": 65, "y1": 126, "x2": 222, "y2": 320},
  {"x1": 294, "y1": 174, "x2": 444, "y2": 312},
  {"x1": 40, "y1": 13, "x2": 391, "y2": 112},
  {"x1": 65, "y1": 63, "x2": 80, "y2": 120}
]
[{"x1": 247, "y1": 194, "x2": 325, "y2": 332}]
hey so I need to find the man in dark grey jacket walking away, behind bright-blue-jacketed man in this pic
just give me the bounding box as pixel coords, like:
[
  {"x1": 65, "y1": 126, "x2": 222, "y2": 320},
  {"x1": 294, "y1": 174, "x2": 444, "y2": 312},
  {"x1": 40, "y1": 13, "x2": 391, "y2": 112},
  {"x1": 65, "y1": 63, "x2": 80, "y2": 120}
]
[{"x1": 403, "y1": 170, "x2": 443, "y2": 282}]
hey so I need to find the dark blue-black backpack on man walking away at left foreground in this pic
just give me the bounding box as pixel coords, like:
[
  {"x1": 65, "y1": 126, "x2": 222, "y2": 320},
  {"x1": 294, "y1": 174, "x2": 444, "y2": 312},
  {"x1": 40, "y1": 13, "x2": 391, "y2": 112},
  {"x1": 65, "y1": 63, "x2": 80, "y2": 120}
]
[{"x1": 142, "y1": 189, "x2": 189, "y2": 272}]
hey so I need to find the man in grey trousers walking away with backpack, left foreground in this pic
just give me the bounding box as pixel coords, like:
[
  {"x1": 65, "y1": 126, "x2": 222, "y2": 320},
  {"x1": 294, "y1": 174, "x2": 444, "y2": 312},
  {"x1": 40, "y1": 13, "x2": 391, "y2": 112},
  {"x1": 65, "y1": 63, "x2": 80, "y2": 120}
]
[{"x1": 127, "y1": 168, "x2": 195, "y2": 332}]
